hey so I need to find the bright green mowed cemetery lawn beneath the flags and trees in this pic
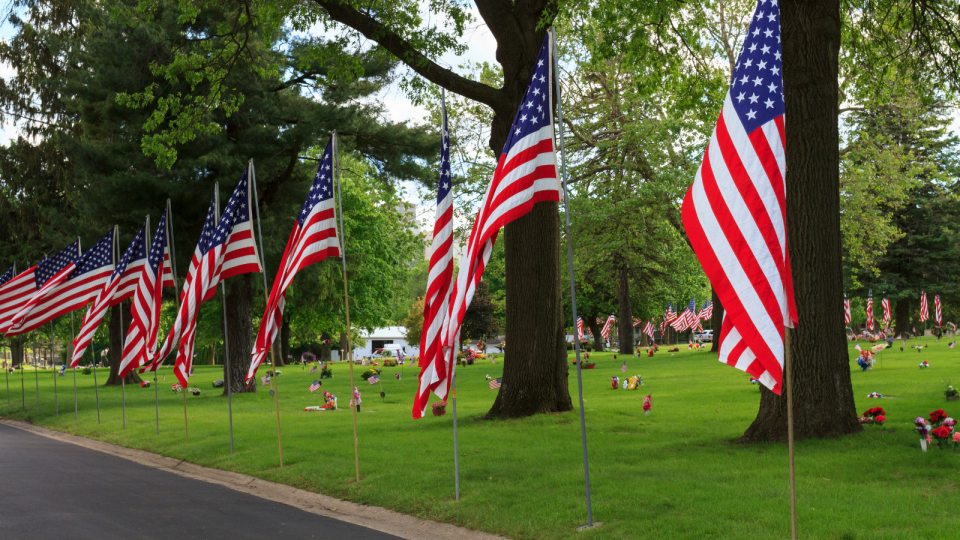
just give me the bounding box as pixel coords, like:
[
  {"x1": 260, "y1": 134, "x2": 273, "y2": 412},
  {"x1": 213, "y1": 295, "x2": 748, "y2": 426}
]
[{"x1": 0, "y1": 338, "x2": 960, "y2": 539}]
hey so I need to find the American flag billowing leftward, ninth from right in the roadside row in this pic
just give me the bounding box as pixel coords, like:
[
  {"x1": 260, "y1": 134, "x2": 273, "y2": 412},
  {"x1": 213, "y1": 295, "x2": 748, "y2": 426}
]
[{"x1": 8, "y1": 234, "x2": 114, "y2": 335}]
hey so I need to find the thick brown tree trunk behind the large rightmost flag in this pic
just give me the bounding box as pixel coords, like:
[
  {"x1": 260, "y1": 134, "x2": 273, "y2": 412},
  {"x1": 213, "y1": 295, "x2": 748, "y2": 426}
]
[{"x1": 741, "y1": 0, "x2": 863, "y2": 441}]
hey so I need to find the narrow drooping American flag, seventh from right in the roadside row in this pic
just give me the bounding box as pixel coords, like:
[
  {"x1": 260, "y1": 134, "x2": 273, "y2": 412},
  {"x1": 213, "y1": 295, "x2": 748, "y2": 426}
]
[{"x1": 120, "y1": 210, "x2": 172, "y2": 378}]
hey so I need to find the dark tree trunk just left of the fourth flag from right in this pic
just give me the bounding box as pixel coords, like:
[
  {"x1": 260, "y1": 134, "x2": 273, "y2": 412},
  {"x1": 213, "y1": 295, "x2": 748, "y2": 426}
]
[{"x1": 223, "y1": 274, "x2": 257, "y2": 395}]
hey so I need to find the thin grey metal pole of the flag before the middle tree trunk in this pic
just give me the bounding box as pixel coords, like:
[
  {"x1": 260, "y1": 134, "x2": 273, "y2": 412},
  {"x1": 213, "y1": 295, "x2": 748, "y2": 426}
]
[{"x1": 548, "y1": 27, "x2": 595, "y2": 529}]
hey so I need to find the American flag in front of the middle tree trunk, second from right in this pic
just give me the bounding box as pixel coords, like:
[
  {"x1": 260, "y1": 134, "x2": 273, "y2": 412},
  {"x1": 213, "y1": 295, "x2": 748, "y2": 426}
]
[{"x1": 434, "y1": 36, "x2": 560, "y2": 399}]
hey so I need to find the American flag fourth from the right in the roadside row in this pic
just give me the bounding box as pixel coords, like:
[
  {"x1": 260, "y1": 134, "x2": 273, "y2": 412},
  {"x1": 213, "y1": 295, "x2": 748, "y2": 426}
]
[{"x1": 247, "y1": 140, "x2": 340, "y2": 384}]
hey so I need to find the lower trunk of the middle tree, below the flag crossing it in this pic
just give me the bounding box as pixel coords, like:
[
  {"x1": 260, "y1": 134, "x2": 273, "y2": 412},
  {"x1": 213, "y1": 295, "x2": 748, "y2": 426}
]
[{"x1": 487, "y1": 202, "x2": 573, "y2": 418}]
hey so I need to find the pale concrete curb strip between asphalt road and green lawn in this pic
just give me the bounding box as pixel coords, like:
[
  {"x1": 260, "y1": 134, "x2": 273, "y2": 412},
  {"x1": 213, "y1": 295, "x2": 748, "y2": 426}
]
[{"x1": 0, "y1": 419, "x2": 508, "y2": 540}]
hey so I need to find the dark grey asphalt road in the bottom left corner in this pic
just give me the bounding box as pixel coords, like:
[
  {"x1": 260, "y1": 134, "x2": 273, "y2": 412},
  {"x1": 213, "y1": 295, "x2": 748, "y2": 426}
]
[{"x1": 0, "y1": 424, "x2": 399, "y2": 540}]
